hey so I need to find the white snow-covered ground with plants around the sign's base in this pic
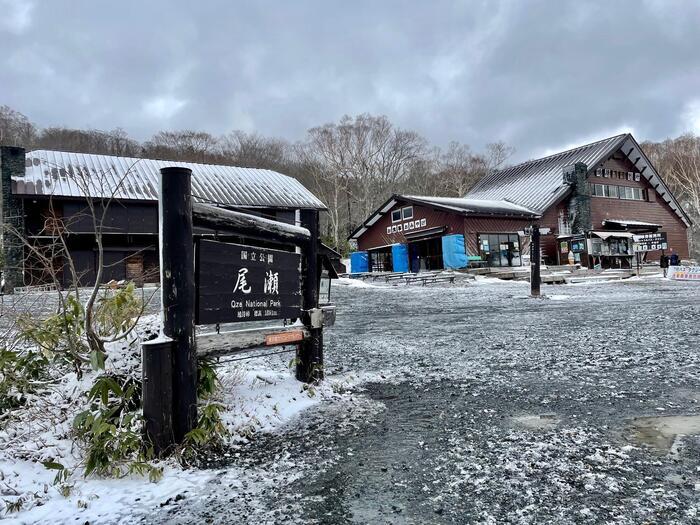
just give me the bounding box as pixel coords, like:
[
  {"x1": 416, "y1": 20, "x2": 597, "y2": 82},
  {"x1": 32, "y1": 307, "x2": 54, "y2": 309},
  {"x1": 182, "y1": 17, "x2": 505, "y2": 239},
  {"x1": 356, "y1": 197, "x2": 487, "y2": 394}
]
[{"x1": 0, "y1": 315, "x2": 356, "y2": 524}]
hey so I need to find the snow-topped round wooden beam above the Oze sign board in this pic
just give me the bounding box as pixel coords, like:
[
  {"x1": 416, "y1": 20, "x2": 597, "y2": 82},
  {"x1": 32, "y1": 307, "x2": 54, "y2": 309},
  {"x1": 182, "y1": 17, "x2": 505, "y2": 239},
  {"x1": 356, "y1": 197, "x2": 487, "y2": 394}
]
[{"x1": 192, "y1": 204, "x2": 311, "y2": 244}]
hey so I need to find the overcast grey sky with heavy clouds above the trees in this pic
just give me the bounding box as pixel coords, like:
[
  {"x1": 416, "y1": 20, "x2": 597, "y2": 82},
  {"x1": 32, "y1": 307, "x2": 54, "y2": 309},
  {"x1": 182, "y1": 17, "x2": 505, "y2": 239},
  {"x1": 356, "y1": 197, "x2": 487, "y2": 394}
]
[{"x1": 0, "y1": 0, "x2": 700, "y2": 160}]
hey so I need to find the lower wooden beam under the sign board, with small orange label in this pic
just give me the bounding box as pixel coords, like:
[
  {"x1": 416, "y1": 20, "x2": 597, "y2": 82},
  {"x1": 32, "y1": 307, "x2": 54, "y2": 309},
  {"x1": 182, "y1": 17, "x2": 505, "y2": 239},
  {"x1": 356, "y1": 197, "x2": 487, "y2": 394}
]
[{"x1": 197, "y1": 325, "x2": 310, "y2": 357}]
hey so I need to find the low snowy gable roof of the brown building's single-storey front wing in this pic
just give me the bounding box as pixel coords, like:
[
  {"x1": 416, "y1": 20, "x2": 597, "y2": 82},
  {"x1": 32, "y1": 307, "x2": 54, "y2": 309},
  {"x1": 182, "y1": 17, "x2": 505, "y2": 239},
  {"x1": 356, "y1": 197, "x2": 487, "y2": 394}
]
[{"x1": 348, "y1": 194, "x2": 540, "y2": 239}]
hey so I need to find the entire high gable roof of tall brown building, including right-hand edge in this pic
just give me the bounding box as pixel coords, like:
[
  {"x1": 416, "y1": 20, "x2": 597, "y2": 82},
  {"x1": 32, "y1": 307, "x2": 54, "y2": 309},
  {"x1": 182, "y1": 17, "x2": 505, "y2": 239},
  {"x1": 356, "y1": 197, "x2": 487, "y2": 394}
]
[{"x1": 465, "y1": 133, "x2": 692, "y2": 226}]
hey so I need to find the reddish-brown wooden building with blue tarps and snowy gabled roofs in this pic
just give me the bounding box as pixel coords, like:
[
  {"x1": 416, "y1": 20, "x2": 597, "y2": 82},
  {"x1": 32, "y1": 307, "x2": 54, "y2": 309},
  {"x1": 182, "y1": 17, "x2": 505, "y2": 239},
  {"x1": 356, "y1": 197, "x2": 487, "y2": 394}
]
[{"x1": 350, "y1": 134, "x2": 691, "y2": 271}]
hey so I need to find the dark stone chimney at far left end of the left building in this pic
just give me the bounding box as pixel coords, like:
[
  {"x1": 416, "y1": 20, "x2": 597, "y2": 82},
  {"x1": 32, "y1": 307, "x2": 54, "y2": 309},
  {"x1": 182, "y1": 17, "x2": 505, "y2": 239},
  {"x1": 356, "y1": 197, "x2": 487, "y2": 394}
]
[{"x1": 0, "y1": 146, "x2": 25, "y2": 293}]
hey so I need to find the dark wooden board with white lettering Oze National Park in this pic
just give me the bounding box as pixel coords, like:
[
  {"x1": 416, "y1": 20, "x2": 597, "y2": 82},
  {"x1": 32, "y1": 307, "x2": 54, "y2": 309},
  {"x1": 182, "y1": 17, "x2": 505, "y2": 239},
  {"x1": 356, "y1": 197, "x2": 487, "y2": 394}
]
[{"x1": 195, "y1": 240, "x2": 301, "y2": 324}]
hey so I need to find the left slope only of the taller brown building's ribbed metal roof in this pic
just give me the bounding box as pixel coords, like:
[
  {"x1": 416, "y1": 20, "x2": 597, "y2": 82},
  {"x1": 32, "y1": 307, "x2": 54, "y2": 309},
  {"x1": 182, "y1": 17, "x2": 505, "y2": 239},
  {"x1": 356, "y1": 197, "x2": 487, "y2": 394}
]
[{"x1": 465, "y1": 133, "x2": 629, "y2": 213}]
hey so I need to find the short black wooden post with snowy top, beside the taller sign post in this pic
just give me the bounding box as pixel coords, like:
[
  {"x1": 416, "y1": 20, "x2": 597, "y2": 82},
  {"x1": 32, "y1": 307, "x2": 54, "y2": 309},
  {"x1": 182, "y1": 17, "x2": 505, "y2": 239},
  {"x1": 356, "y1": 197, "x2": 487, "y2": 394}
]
[{"x1": 141, "y1": 336, "x2": 175, "y2": 457}]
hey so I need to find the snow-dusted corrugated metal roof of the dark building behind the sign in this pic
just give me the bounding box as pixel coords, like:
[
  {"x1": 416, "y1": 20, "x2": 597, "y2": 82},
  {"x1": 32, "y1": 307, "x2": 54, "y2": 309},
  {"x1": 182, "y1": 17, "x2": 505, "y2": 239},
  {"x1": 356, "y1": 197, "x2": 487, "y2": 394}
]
[{"x1": 12, "y1": 150, "x2": 326, "y2": 209}]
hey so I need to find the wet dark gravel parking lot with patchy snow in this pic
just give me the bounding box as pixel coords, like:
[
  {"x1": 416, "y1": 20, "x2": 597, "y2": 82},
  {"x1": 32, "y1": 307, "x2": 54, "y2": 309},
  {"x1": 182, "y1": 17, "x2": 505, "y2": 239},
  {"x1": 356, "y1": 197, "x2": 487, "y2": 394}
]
[{"x1": 141, "y1": 277, "x2": 700, "y2": 524}]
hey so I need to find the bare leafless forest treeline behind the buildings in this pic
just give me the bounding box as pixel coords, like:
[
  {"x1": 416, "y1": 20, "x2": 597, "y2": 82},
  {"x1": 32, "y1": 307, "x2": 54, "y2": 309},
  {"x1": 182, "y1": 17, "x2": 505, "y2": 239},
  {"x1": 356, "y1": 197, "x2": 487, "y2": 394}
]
[{"x1": 0, "y1": 106, "x2": 700, "y2": 252}]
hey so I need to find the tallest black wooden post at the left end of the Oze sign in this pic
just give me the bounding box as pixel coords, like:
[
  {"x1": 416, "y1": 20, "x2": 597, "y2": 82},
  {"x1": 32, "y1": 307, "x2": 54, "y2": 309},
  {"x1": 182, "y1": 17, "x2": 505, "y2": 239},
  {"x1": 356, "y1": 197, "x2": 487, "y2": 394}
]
[{"x1": 158, "y1": 167, "x2": 197, "y2": 443}]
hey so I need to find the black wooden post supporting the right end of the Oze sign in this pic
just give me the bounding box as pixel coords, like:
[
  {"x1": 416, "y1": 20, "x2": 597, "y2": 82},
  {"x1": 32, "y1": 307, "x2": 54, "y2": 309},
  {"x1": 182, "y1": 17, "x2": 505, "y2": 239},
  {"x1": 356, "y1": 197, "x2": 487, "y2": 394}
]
[{"x1": 296, "y1": 210, "x2": 323, "y2": 383}]
